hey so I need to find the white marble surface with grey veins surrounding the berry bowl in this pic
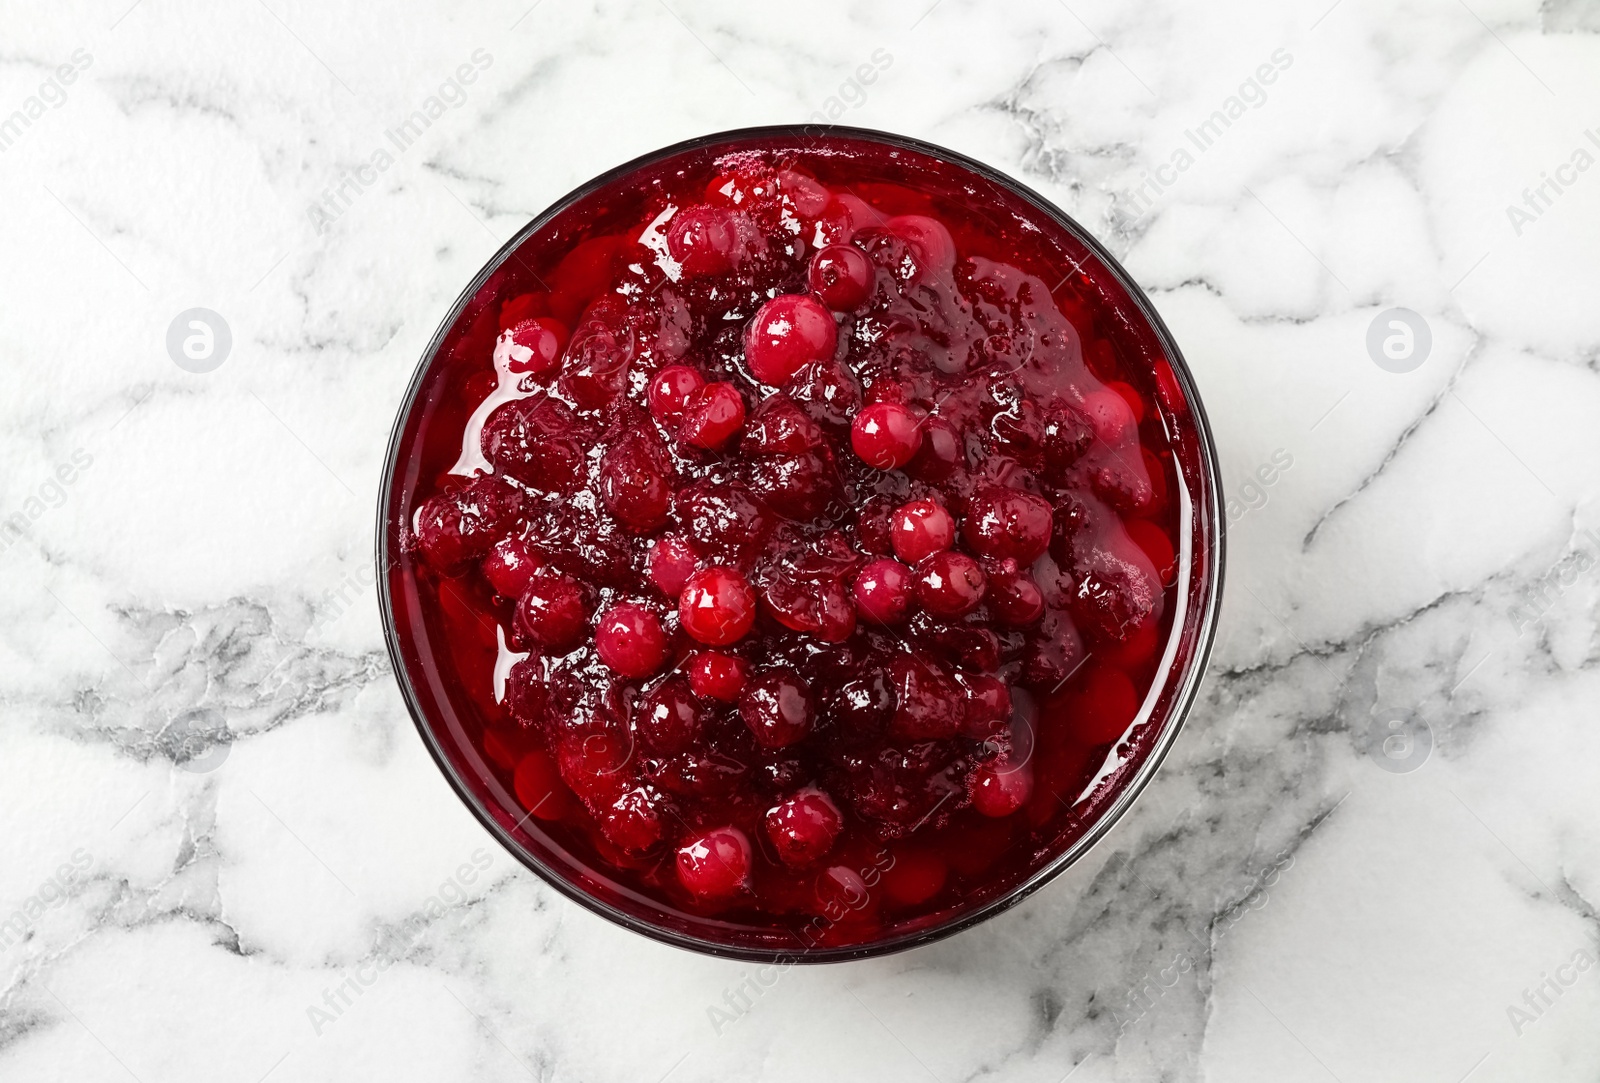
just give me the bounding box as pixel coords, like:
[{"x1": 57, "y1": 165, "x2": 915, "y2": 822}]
[{"x1": 0, "y1": 0, "x2": 1600, "y2": 1083}]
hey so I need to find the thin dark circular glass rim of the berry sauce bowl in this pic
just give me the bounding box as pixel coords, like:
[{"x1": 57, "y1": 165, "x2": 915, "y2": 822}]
[{"x1": 374, "y1": 123, "x2": 1227, "y2": 966}]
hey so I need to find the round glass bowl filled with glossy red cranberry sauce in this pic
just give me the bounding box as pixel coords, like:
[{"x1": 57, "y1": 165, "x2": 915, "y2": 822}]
[{"x1": 384, "y1": 130, "x2": 1219, "y2": 958}]
